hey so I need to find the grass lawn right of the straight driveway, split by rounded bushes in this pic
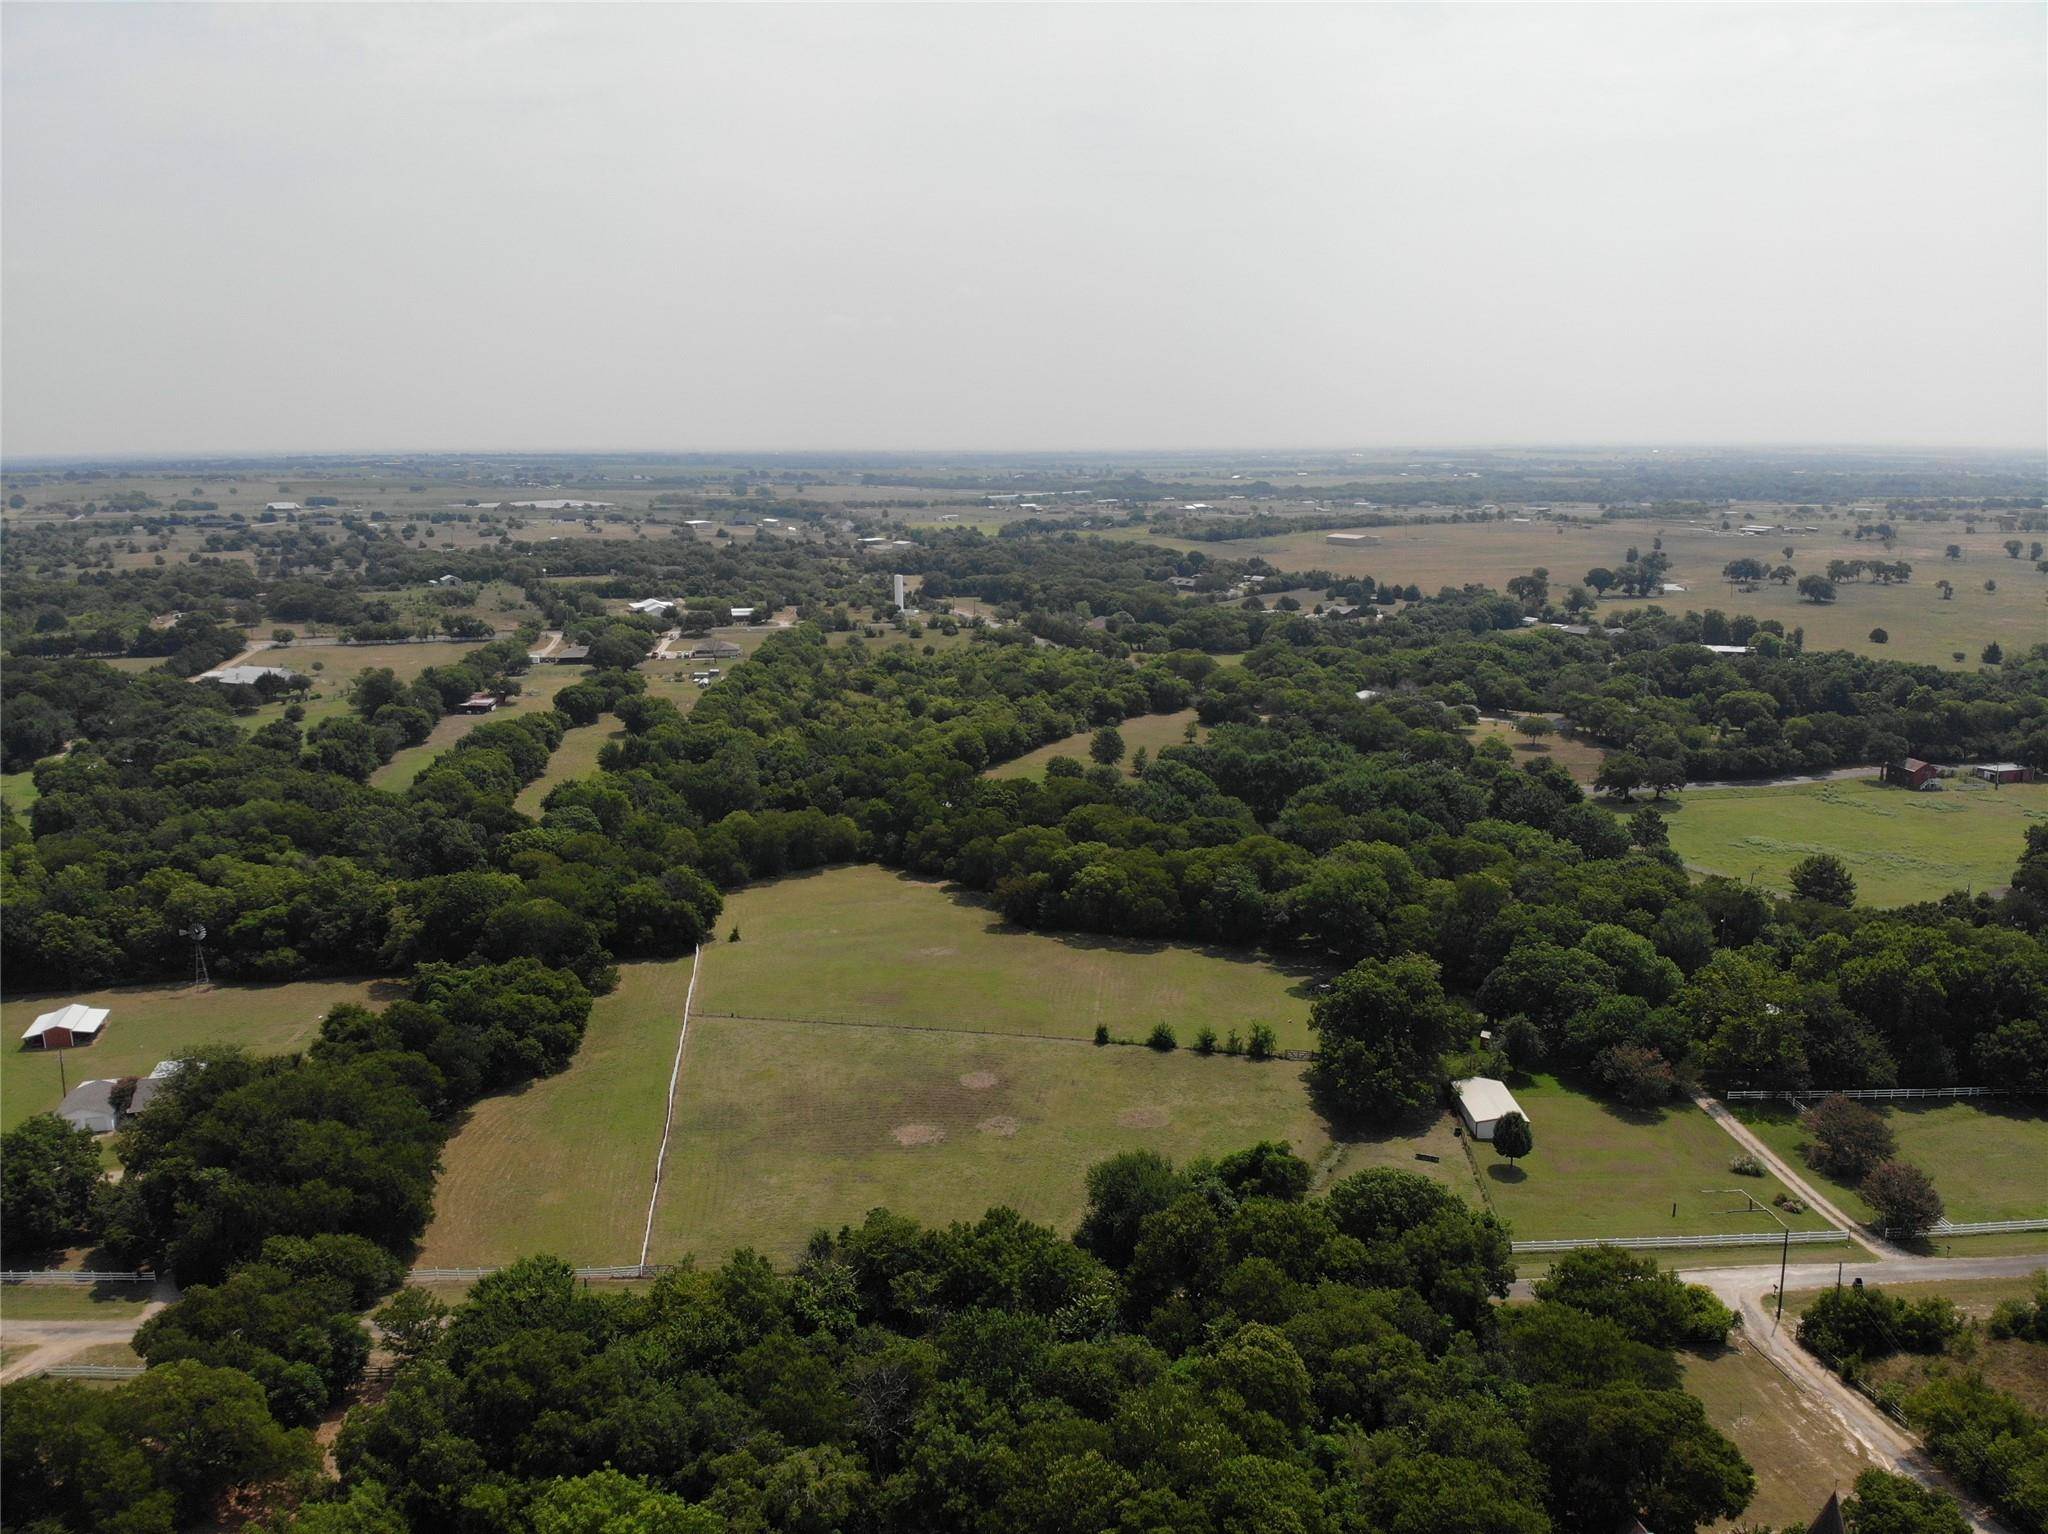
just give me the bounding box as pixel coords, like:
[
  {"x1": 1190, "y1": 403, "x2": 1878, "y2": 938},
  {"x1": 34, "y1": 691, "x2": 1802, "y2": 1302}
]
[{"x1": 1731, "y1": 1100, "x2": 2048, "y2": 1220}]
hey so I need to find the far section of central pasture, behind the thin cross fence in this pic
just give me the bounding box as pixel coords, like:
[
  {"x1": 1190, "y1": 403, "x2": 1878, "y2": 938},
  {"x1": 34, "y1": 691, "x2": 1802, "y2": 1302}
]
[{"x1": 696, "y1": 866, "x2": 1321, "y2": 1049}]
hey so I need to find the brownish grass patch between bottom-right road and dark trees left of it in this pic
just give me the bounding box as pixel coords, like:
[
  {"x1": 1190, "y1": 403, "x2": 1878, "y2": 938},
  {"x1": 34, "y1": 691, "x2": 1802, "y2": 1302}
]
[{"x1": 1679, "y1": 1341, "x2": 1878, "y2": 1528}]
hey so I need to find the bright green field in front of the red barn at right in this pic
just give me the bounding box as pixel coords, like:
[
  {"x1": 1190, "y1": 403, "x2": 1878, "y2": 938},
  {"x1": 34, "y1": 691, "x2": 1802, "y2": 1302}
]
[{"x1": 1663, "y1": 778, "x2": 2048, "y2": 905}]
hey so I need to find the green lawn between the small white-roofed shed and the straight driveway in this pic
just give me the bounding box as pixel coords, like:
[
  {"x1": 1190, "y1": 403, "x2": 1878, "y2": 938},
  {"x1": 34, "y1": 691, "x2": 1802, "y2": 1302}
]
[{"x1": 1473, "y1": 1075, "x2": 1827, "y2": 1237}]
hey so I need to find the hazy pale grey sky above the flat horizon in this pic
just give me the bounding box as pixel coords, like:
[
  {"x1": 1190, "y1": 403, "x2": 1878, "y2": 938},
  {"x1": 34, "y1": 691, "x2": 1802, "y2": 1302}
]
[{"x1": 0, "y1": 0, "x2": 2048, "y2": 455}]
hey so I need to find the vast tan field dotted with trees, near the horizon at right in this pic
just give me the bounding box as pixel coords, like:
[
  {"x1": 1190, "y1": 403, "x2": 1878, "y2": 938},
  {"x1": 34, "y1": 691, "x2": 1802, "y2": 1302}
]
[{"x1": 1146, "y1": 508, "x2": 2048, "y2": 668}]
